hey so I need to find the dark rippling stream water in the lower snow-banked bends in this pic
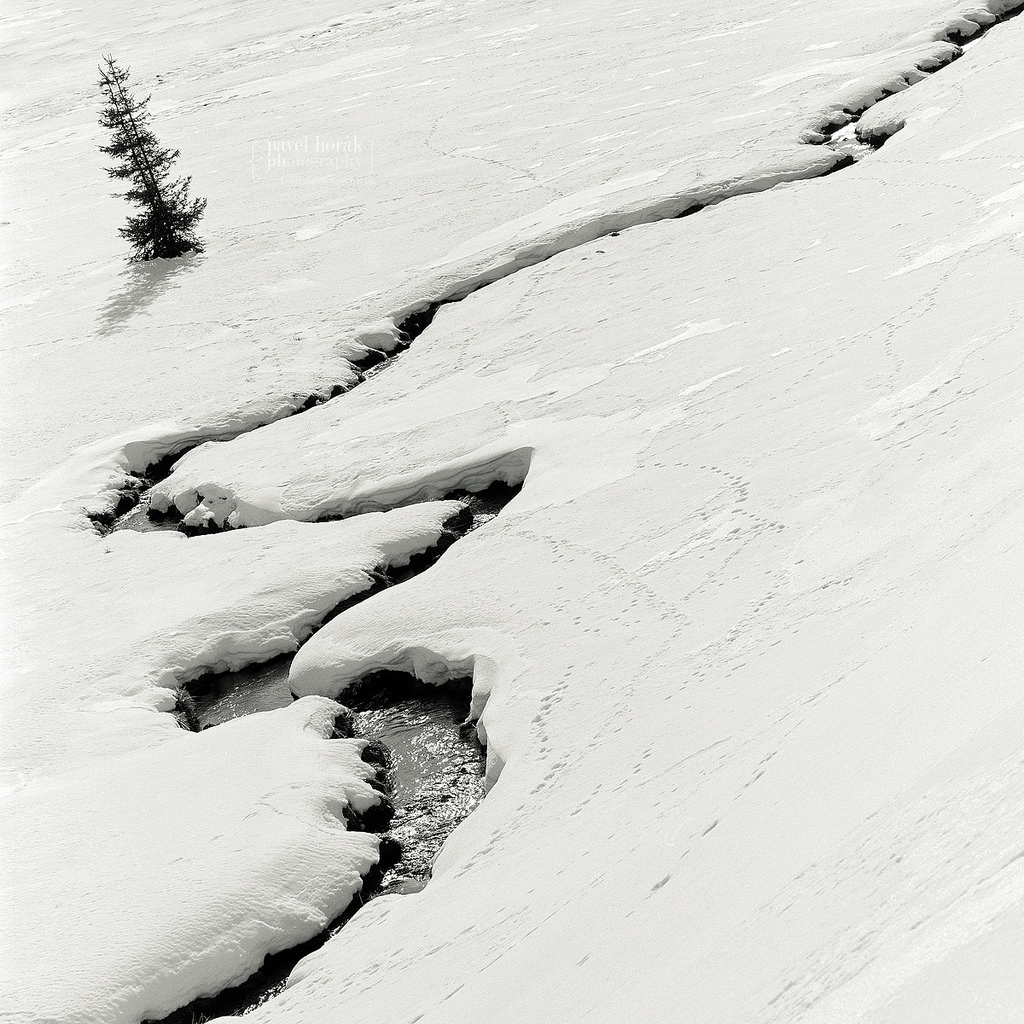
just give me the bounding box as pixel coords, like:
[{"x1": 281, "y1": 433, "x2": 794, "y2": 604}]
[{"x1": 135, "y1": 481, "x2": 521, "y2": 1024}]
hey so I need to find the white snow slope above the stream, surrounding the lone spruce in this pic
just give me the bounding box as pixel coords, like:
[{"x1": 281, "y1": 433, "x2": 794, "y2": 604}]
[{"x1": 0, "y1": 0, "x2": 991, "y2": 498}]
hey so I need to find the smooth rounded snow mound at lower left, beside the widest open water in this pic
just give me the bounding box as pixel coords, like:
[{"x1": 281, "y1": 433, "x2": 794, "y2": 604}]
[{"x1": 4, "y1": 698, "x2": 378, "y2": 1021}]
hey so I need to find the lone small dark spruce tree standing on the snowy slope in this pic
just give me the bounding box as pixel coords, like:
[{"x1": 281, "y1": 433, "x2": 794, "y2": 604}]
[{"x1": 99, "y1": 56, "x2": 206, "y2": 263}]
